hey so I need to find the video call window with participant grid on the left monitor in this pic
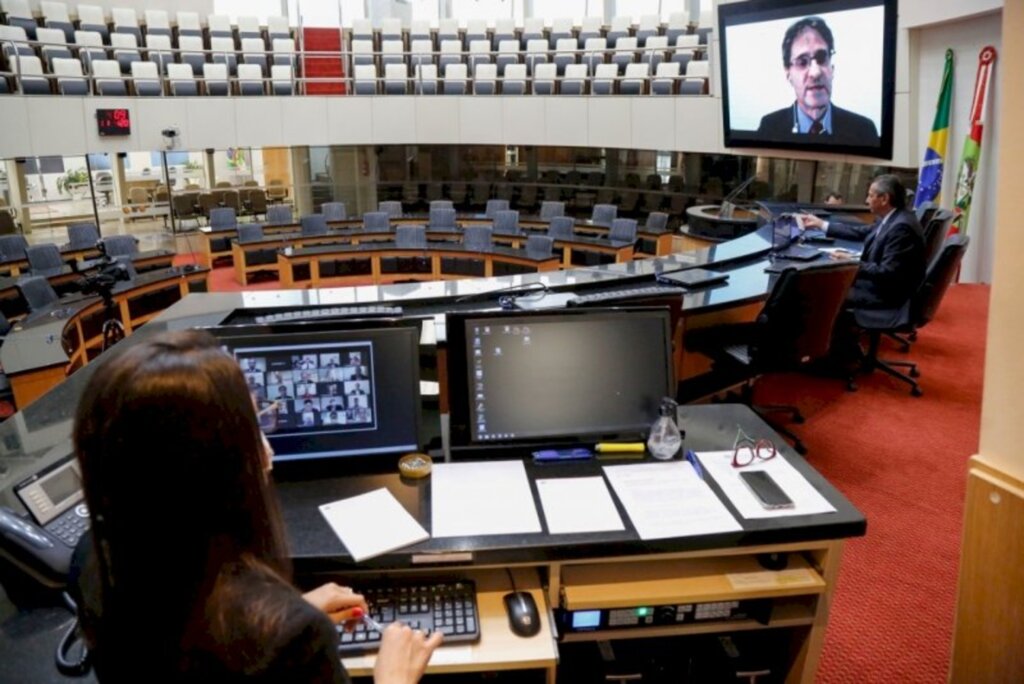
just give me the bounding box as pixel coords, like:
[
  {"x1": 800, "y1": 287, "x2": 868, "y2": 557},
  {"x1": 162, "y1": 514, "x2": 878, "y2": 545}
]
[{"x1": 233, "y1": 341, "x2": 378, "y2": 436}]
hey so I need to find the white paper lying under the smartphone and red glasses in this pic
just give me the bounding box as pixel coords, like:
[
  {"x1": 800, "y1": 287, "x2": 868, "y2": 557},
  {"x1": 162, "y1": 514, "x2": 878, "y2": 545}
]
[{"x1": 697, "y1": 450, "x2": 836, "y2": 518}]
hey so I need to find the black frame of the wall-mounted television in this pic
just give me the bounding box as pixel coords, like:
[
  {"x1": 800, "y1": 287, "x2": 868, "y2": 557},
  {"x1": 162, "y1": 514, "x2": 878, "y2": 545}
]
[{"x1": 718, "y1": 0, "x2": 898, "y2": 160}]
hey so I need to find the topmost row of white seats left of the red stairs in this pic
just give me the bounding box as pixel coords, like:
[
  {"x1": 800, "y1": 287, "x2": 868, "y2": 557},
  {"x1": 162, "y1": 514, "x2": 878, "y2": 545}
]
[{"x1": 0, "y1": 0, "x2": 291, "y2": 45}]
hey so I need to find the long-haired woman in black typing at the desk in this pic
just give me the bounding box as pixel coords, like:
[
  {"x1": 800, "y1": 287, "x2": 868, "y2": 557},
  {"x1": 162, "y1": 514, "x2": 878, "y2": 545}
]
[{"x1": 75, "y1": 332, "x2": 440, "y2": 684}]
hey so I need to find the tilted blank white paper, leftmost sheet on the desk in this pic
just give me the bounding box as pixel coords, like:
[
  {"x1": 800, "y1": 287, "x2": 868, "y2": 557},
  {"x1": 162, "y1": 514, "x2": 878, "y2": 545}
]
[{"x1": 319, "y1": 487, "x2": 430, "y2": 563}]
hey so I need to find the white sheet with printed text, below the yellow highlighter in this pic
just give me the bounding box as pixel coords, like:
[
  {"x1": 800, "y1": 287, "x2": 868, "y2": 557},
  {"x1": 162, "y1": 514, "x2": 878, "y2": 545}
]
[{"x1": 604, "y1": 461, "x2": 741, "y2": 540}]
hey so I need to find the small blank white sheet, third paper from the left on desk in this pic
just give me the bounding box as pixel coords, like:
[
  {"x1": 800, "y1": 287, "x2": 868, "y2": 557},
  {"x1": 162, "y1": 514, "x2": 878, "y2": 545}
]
[{"x1": 536, "y1": 477, "x2": 626, "y2": 535}]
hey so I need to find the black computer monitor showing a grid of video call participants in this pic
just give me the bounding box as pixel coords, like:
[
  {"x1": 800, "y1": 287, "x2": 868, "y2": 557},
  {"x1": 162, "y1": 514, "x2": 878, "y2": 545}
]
[{"x1": 211, "y1": 320, "x2": 420, "y2": 467}]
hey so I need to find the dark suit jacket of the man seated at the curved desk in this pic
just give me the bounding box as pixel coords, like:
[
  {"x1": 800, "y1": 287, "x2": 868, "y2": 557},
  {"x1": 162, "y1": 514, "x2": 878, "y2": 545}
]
[{"x1": 828, "y1": 205, "x2": 925, "y2": 308}]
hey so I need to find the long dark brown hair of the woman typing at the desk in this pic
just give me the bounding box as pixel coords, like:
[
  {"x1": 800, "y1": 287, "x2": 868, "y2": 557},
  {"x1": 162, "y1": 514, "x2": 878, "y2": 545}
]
[{"x1": 75, "y1": 332, "x2": 291, "y2": 677}]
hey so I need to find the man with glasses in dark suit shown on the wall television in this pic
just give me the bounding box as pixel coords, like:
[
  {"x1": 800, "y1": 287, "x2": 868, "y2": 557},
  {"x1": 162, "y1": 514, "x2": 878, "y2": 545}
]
[{"x1": 758, "y1": 16, "x2": 879, "y2": 145}]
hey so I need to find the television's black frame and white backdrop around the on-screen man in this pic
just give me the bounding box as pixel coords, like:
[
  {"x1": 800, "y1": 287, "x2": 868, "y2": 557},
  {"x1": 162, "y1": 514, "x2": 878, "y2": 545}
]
[{"x1": 719, "y1": 0, "x2": 895, "y2": 157}]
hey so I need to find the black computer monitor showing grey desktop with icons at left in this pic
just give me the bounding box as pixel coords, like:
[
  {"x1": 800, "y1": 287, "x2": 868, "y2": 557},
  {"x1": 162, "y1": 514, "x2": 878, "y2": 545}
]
[{"x1": 446, "y1": 308, "x2": 675, "y2": 450}]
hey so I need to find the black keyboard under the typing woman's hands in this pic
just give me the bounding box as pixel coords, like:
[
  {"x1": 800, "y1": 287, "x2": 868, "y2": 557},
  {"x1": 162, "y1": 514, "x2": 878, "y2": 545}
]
[{"x1": 338, "y1": 580, "x2": 480, "y2": 657}]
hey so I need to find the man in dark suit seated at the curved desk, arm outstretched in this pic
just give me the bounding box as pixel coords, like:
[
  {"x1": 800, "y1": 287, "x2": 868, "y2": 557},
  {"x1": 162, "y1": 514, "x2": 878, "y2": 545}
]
[{"x1": 800, "y1": 174, "x2": 925, "y2": 308}]
